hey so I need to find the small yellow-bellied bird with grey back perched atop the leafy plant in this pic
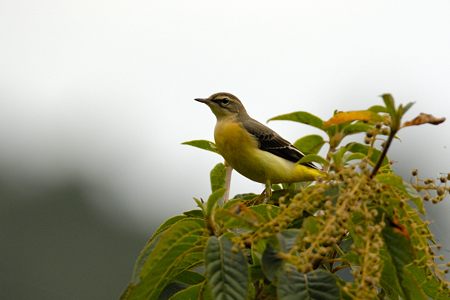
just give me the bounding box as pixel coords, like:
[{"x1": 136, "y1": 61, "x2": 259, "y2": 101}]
[{"x1": 194, "y1": 92, "x2": 323, "y2": 198}]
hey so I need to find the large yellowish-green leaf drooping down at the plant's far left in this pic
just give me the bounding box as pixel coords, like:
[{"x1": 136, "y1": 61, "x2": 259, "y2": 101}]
[{"x1": 122, "y1": 218, "x2": 206, "y2": 300}]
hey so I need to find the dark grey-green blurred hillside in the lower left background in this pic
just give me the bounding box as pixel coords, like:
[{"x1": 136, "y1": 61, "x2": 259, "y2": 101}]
[{"x1": 0, "y1": 174, "x2": 153, "y2": 300}]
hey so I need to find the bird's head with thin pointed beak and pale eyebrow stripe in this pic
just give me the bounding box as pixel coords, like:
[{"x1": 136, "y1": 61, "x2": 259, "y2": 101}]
[{"x1": 195, "y1": 93, "x2": 247, "y2": 120}]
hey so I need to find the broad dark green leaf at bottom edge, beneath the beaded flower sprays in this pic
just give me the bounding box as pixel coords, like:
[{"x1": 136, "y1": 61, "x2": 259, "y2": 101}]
[{"x1": 277, "y1": 267, "x2": 341, "y2": 300}]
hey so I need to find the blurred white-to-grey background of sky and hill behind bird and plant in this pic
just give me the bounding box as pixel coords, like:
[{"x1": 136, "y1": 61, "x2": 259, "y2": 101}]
[{"x1": 0, "y1": 0, "x2": 450, "y2": 300}]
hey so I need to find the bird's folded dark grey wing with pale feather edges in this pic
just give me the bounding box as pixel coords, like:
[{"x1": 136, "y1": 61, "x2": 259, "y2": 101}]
[{"x1": 242, "y1": 118, "x2": 317, "y2": 169}]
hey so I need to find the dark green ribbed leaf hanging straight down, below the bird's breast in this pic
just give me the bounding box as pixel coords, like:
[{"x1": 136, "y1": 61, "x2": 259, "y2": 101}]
[{"x1": 205, "y1": 236, "x2": 249, "y2": 300}]
